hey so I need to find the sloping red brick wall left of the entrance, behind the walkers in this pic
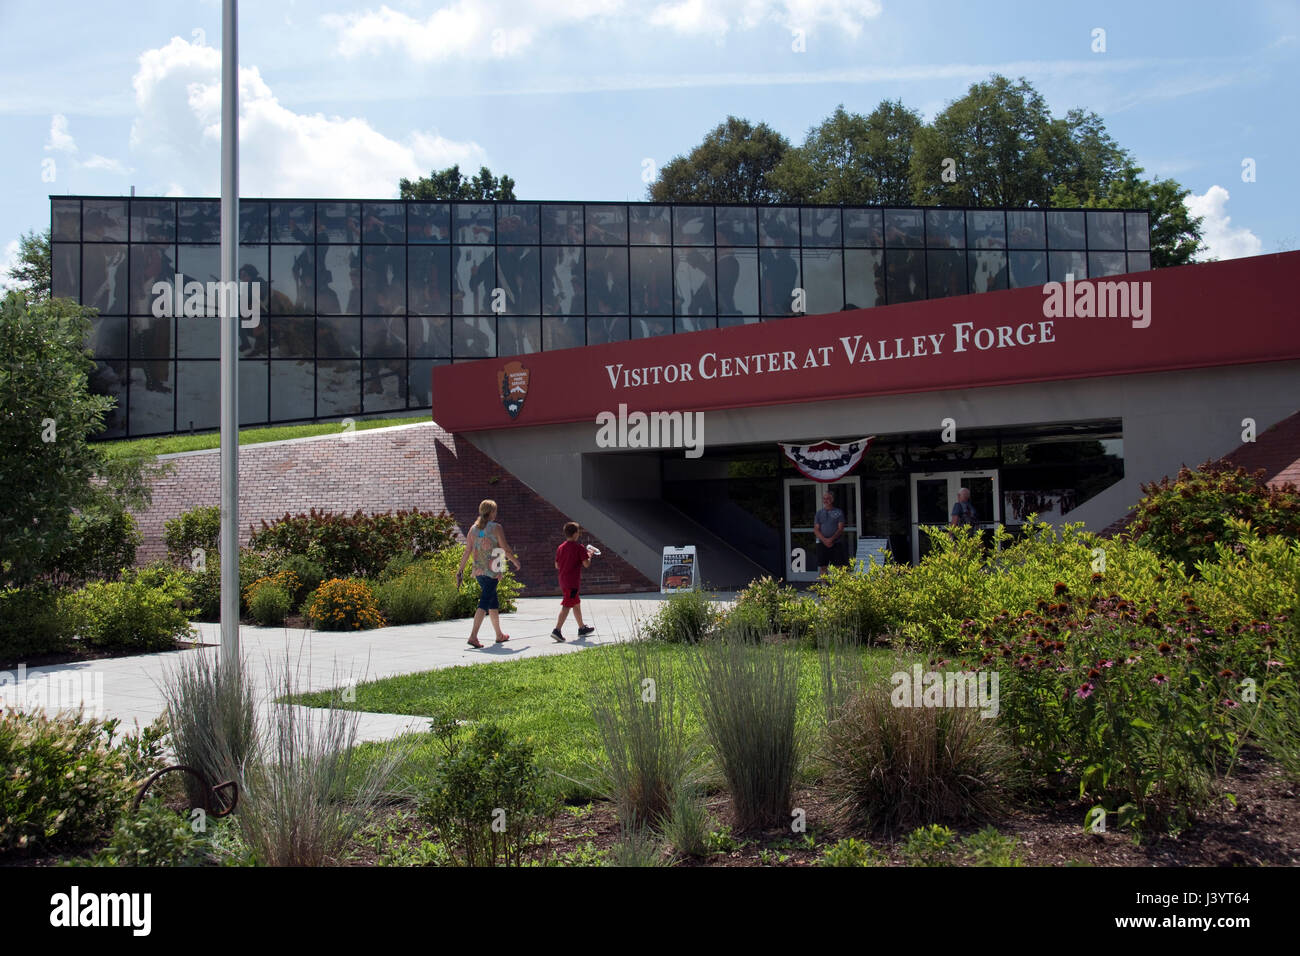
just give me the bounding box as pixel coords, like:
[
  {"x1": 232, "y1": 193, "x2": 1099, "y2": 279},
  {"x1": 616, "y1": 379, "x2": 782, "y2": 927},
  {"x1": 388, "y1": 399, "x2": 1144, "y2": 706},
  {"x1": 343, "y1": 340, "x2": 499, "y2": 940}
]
[{"x1": 137, "y1": 423, "x2": 655, "y2": 596}]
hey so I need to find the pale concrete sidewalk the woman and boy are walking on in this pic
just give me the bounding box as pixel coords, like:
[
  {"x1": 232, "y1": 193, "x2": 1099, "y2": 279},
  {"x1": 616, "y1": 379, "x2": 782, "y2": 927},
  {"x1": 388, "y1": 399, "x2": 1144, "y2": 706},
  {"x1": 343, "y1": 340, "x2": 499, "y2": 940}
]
[{"x1": 0, "y1": 594, "x2": 666, "y2": 740}]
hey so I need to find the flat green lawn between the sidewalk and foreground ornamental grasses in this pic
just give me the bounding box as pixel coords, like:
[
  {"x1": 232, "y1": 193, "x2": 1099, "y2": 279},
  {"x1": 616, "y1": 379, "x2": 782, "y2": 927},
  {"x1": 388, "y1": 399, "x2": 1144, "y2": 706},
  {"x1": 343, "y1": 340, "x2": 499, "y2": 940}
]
[{"x1": 295, "y1": 644, "x2": 910, "y2": 799}]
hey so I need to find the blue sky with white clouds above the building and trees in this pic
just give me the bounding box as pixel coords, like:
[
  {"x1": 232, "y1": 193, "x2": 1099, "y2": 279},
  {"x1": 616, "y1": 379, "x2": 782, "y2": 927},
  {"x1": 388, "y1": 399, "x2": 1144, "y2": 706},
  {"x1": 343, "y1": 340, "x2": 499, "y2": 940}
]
[{"x1": 0, "y1": 0, "x2": 1300, "y2": 280}]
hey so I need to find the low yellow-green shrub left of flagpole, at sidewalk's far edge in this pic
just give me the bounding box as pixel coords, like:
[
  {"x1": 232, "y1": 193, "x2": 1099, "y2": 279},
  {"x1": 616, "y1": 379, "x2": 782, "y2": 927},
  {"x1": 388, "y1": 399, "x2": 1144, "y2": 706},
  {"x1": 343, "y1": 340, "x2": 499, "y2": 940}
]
[{"x1": 65, "y1": 578, "x2": 191, "y2": 650}]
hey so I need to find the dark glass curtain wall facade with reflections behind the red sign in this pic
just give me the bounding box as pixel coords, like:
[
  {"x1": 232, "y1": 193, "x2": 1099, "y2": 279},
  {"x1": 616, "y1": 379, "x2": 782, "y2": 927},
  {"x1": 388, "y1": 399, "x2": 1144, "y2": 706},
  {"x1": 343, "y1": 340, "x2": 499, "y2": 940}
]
[{"x1": 51, "y1": 196, "x2": 1151, "y2": 437}]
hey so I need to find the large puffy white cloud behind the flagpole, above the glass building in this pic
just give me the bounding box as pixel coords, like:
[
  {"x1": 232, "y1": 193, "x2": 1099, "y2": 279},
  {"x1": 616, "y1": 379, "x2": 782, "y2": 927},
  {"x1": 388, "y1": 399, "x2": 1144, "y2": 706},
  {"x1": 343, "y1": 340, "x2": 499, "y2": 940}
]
[{"x1": 131, "y1": 36, "x2": 485, "y2": 198}]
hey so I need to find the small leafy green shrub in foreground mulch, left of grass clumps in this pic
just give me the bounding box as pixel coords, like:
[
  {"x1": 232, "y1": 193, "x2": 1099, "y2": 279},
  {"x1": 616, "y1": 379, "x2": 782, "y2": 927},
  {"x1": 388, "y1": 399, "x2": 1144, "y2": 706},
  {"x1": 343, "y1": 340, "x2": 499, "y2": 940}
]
[{"x1": 420, "y1": 723, "x2": 555, "y2": 866}]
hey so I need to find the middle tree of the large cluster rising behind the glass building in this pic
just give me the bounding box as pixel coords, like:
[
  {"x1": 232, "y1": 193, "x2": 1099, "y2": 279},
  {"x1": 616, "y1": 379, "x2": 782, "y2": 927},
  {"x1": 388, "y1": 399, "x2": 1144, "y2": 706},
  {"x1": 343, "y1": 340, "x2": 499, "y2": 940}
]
[{"x1": 771, "y1": 100, "x2": 922, "y2": 206}]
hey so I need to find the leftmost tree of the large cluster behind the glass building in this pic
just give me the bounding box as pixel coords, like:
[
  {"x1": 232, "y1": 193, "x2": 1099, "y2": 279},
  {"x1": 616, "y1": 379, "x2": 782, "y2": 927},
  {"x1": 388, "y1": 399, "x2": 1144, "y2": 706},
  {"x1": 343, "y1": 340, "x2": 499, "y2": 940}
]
[{"x1": 646, "y1": 116, "x2": 790, "y2": 203}]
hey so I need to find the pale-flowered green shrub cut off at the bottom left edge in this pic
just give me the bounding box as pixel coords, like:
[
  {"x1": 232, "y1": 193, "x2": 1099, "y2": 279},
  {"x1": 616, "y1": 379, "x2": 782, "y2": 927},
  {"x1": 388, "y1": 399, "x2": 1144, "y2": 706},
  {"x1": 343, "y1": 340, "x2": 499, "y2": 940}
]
[{"x1": 0, "y1": 710, "x2": 130, "y2": 851}]
